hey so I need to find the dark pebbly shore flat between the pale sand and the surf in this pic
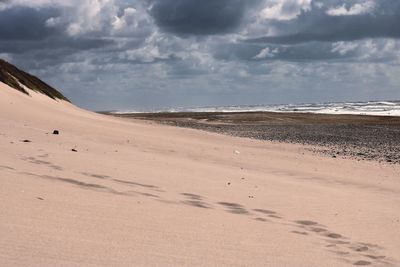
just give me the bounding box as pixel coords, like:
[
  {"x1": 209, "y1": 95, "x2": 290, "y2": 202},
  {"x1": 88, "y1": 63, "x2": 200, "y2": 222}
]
[{"x1": 106, "y1": 112, "x2": 400, "y2": 164}]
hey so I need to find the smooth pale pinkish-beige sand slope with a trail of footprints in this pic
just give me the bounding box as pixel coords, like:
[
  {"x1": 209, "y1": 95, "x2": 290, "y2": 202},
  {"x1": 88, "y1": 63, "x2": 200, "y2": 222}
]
[{"x1": 0, "y1": 82, "x2": 400, "y2": 266}]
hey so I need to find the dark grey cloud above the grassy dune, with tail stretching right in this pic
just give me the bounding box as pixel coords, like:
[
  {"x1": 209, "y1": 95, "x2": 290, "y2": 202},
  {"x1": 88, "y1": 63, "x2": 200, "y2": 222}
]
[{"x1": 0, "y1": 1, "x2": 115, "y2": 62}]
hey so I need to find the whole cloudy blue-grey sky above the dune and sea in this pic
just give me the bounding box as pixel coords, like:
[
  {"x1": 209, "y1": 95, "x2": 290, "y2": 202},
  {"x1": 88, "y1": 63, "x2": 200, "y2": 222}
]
[{"x1": 0, "y1": 0, "x2": 400, "y2": 110}]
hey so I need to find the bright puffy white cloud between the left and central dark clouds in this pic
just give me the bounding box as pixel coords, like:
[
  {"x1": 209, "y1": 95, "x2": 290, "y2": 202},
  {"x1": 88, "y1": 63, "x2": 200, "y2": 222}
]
[{"x1": 22, "y1": 0, "x2": 154, "y2": 37}]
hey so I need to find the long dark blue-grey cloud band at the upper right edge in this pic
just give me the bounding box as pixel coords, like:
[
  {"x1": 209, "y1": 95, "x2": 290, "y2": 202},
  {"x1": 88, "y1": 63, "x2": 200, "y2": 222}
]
[{"x1": 246, "y1": 0, "x2": 400, "y2": 44}]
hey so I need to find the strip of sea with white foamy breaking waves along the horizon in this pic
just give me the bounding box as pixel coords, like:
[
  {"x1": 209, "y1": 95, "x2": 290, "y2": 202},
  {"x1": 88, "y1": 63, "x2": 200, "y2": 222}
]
[{"x1": 112, "y1": 100, "x2": 400, "y2": 116}]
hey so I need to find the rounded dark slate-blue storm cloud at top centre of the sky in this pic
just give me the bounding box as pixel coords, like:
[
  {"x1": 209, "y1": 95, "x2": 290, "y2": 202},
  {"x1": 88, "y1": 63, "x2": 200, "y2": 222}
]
[{"x1": 150, "y1": 0, "x2": 257, "y2": 35}]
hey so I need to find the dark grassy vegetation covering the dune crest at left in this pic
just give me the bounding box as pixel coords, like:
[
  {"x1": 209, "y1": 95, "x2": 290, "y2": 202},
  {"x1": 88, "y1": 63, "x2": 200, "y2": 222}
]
[{"x1": 0, "y1": 59, "x2": 70, "y2": 102}]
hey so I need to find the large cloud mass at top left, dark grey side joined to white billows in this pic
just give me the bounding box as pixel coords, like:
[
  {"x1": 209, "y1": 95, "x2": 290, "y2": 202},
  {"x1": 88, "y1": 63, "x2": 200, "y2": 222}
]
[{"x1": 0, "y1": 0, "x2": 153, "y2": 54}]
